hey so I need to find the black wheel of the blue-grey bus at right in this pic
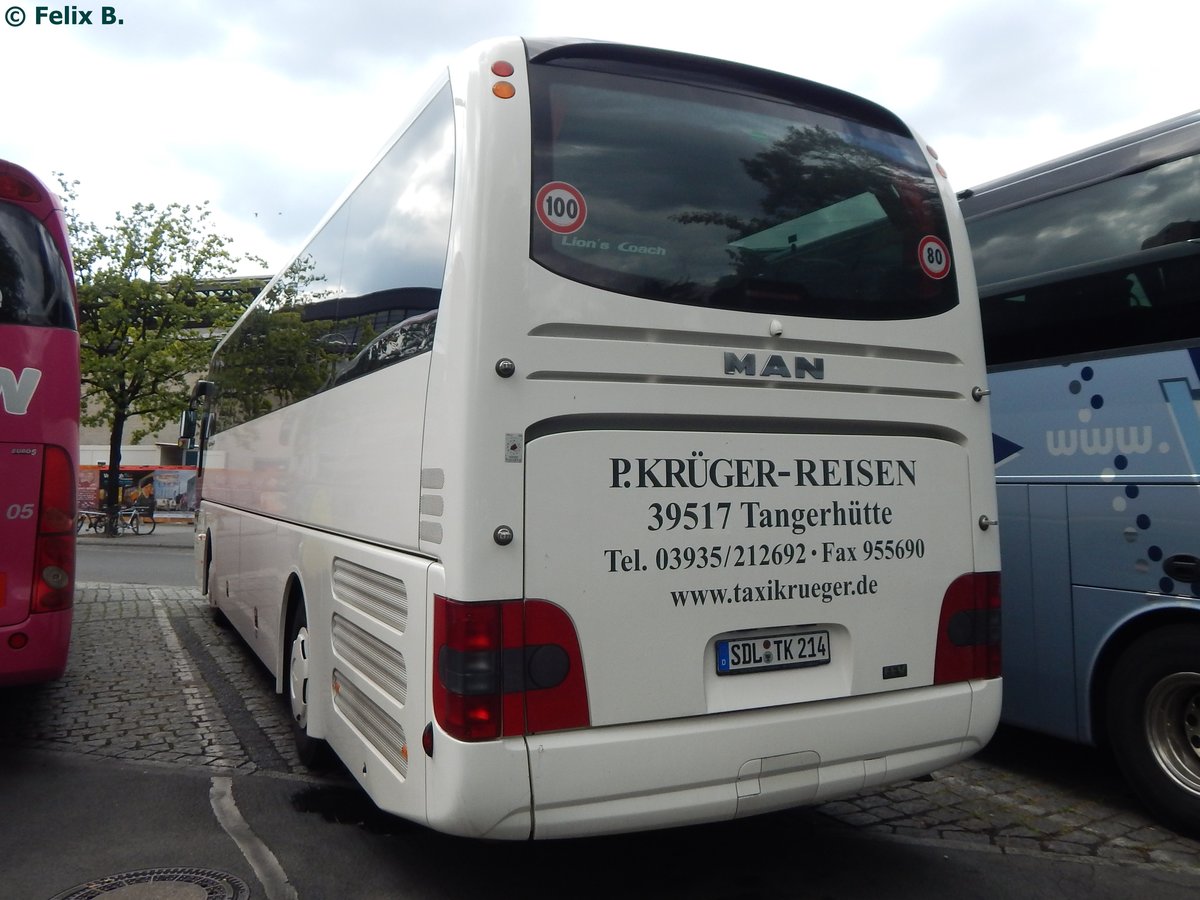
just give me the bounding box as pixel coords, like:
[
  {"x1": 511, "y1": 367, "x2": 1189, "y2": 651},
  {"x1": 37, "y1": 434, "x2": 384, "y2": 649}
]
[{"x1": 1108, "y1": 625, "x2": 1200, "y2": 834}]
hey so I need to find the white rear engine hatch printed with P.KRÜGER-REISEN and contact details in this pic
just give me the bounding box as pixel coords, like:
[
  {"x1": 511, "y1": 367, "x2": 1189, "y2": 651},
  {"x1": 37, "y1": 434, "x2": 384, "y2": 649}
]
[{"x1": 526, "y1": 431, "x2": 972, "y2": 724}]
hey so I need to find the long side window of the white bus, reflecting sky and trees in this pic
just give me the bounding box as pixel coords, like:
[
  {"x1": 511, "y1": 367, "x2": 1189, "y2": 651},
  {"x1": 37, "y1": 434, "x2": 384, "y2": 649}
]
[{"x1": 212, "y1": 85, "x2": 455, "y2": 430}]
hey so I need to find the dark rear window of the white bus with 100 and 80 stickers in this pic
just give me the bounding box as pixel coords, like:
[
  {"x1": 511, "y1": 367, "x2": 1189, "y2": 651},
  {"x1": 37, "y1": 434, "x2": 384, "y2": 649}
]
[{"x1": 530, "y1": 62, "x2": 958, "y2": 319}]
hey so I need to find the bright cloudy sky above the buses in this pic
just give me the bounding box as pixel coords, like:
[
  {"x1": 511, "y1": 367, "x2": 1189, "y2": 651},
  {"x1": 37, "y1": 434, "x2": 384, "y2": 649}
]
[{"x1": 0, "y1": 0, "x2": 1200, "y2": 269}]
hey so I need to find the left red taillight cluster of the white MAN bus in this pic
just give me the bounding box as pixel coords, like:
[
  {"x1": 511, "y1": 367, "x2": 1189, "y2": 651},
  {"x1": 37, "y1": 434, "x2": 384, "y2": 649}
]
[{"x1": 433, "y1": 596, "x2": 590, "y2": 740}]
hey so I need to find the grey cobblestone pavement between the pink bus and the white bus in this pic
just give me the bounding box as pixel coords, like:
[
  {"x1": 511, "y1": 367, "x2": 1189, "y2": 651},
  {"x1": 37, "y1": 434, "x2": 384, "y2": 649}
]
[{"x1": 0, "y1": 584, "x2": 305, "y2": 773}]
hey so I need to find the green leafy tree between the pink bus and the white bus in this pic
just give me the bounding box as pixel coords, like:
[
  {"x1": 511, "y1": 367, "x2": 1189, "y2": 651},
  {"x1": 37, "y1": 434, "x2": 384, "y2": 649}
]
[{"x1": 59, "y1": 176, "x2": 265, "y2": 532}]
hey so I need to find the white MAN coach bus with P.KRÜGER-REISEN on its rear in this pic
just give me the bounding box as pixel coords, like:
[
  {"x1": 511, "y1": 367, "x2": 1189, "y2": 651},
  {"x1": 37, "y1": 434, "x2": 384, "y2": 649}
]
[{"x1": 187, "y1": 40, "x2": 1001, "y2": 839}]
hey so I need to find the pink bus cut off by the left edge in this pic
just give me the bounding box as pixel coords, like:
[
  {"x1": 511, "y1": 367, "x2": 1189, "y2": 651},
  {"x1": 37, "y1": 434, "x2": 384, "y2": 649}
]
[{"x1": 0, "y1": 160, "x2": 79, "y2": 685}]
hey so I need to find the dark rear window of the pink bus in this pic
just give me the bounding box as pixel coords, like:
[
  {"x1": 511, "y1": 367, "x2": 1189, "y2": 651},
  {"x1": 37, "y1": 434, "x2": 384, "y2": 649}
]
[{"x1": 0, "y1": 203, "x2": 76, "y2": 328}]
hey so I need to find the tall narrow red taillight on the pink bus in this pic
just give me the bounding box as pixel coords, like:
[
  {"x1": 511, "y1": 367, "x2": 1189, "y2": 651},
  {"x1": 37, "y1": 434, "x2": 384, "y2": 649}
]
[{"x1": 30, "y1": 445, "x2": 76, "y2": 612}]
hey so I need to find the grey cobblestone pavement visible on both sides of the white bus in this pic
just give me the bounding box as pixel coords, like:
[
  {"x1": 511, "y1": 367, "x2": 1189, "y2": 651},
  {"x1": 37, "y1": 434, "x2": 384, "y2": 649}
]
[{"x1": 0, "y1": 583, "x2": 1200, "y2": 874}]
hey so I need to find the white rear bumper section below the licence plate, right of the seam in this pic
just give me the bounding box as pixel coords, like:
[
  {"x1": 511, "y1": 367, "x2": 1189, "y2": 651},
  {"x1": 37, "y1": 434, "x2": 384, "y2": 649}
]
[{"x1": 528, "y1": 679, "x2": 1001, "y2": 838}]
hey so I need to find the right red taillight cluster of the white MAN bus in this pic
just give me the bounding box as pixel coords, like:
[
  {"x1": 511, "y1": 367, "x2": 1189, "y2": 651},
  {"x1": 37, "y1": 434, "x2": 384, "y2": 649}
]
[{"x1": 934, "y1": 572, "x2": 1000, "y2": 684}]
